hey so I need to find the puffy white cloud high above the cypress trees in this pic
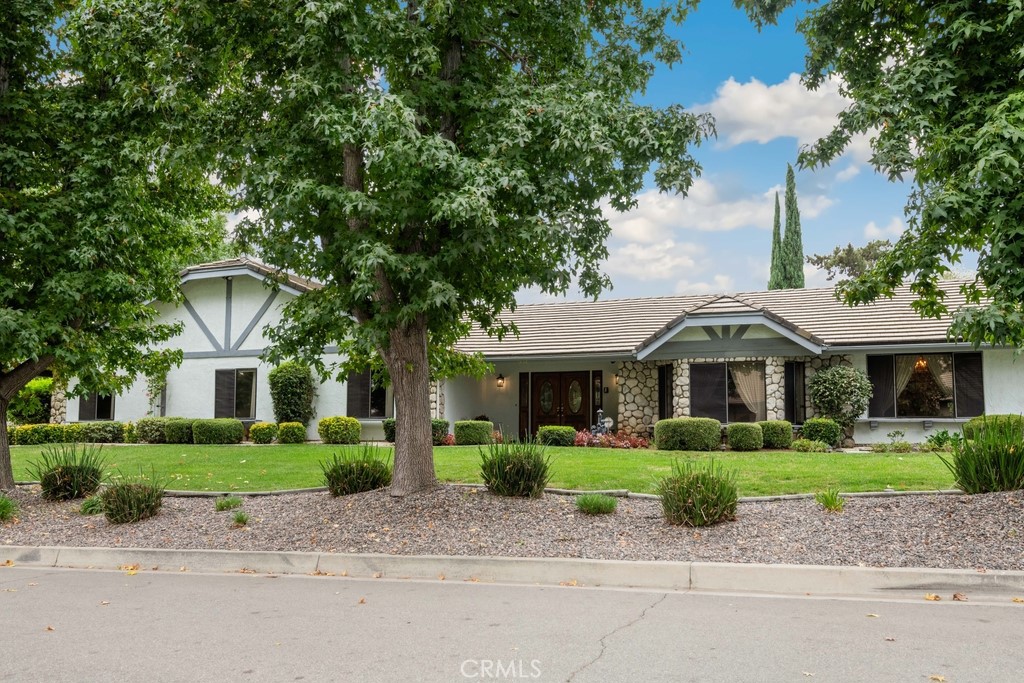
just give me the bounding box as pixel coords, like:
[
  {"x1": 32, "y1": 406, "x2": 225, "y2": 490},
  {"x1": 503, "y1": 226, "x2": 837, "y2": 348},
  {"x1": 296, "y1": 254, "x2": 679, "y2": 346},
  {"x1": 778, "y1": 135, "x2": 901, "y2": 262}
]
[{"x1": 693, "y1": 74, "x2": 871, "y2": 164}]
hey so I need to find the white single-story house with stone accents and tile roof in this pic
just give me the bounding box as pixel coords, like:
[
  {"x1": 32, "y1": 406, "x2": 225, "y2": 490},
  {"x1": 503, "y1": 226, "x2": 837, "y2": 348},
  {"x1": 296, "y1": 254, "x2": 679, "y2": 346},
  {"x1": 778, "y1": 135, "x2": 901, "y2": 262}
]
[{"x1": 68, "y1": 258, "x2": 1024, "y2": 443}]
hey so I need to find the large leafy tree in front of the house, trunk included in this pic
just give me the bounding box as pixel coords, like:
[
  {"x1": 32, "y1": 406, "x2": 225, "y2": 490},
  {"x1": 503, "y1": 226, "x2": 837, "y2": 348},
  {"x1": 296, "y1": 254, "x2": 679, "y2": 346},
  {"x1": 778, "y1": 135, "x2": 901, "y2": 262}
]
[{"x1": 98, "y1": 0, "x2": 713, "y2": 495}]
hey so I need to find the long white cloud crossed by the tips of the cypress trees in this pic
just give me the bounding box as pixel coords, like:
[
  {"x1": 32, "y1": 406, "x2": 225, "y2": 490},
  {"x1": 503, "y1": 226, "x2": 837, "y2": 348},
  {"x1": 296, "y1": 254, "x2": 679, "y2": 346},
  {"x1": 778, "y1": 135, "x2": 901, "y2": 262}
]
[{"x1": 605, "y1": 178, "x2": 834, "y2": 237}]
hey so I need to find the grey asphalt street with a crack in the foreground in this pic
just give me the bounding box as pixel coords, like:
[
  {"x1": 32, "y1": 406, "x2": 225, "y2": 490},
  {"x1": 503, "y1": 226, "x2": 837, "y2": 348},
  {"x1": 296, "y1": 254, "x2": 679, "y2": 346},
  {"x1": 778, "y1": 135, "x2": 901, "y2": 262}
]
[{"x1": 0, "y1": 566, "x2": 1024, "y2": 683}]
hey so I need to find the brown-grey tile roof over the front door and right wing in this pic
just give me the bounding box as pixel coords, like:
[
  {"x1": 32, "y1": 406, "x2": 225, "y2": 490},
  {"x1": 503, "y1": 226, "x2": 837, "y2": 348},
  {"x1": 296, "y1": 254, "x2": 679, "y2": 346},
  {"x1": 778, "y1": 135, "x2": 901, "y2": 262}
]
[{"x1": 458, "y1": 282, "x2": 965, "y2": 358}]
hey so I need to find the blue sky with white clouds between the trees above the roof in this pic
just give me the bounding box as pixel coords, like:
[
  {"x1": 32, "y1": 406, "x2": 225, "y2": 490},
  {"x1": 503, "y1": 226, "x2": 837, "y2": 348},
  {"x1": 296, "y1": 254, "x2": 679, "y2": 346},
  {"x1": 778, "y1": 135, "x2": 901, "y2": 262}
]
[{"x1": 519, "y1": 0, "x2": 909, "y2": 303}]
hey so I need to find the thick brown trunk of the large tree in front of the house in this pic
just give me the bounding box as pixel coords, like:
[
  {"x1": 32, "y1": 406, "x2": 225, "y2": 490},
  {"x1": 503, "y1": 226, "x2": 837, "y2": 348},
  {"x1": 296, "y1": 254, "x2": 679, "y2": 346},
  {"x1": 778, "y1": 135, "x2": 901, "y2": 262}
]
[{"x1": 381, "y1": 316, "x2": 437, "y2": 496}]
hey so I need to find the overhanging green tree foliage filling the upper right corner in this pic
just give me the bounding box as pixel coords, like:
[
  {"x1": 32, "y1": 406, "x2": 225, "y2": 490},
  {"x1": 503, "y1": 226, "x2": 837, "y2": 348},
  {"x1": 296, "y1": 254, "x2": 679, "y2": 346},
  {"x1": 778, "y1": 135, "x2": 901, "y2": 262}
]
[{"x1": 734, "y1": 0, "x2": 1024, "y2": 347}]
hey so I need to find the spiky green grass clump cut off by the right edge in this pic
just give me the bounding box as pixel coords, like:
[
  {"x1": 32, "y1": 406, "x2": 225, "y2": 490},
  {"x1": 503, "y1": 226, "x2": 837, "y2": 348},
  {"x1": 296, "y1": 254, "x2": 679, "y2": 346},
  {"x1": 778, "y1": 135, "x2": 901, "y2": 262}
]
[{"x1": 939, "y1": 413, "x2": 1024, "y2": 494}]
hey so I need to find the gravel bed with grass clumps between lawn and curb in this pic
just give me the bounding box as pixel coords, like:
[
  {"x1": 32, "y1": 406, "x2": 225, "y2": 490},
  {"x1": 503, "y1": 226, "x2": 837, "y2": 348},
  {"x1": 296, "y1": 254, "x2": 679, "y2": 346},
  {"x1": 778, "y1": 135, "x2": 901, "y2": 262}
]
[{"x1": 0, "y1": 485, "x2": 1024, "y2": 569}]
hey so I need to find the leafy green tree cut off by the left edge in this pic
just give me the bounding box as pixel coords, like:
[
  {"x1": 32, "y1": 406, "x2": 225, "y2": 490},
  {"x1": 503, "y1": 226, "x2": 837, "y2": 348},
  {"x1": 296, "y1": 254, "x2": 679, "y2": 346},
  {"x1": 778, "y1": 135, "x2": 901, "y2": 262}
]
[{"x1": 0, "y1": 0, "x2": 219, "y2": 488}]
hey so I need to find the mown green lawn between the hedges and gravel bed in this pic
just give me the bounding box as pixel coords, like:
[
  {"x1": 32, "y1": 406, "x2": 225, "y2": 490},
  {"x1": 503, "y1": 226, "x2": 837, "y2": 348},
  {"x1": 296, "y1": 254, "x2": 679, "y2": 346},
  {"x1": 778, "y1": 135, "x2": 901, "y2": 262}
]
[{"x1": 11, "y1": 444, "x2": 953, "y2": 496}]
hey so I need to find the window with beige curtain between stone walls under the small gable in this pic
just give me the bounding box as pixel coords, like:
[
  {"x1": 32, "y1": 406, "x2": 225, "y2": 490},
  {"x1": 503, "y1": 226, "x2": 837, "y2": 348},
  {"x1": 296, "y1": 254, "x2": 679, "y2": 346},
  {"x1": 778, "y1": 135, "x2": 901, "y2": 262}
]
[{"x1": 690, "y1": 360, "x2": 767, "y2": 422}]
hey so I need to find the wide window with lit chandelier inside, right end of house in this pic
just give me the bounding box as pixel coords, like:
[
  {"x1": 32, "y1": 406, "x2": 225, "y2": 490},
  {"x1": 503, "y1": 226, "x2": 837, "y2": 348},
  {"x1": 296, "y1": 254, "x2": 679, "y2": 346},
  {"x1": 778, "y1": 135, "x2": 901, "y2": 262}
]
[{"x1": 867, "y1": 353, "x2": 985, "y2": 418}]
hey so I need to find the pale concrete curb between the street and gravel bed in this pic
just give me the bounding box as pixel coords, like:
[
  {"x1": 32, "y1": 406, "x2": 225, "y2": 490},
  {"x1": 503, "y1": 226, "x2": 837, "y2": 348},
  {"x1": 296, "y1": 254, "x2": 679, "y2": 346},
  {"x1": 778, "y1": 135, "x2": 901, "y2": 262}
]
[{"x1": 0, "y1": 546, "x2": 1024, "y2": 597}]
